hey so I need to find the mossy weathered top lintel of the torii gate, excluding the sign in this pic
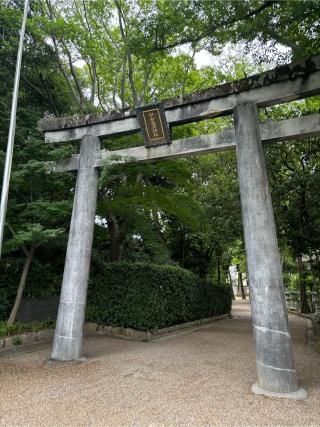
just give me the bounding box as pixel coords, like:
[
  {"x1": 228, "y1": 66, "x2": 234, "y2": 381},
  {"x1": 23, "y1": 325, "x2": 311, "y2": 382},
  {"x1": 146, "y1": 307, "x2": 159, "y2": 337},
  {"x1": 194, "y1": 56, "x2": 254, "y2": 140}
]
[{"x1": 39, "y1": 54, "x2": 320, "y2": 143}]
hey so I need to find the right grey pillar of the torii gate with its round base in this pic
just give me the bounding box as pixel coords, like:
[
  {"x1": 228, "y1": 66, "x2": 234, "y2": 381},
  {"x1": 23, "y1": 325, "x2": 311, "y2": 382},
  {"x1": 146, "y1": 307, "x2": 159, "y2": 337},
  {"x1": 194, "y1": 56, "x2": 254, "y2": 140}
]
[{"x1": 234, "y1": 102, "x2": 306, "y2": 399}]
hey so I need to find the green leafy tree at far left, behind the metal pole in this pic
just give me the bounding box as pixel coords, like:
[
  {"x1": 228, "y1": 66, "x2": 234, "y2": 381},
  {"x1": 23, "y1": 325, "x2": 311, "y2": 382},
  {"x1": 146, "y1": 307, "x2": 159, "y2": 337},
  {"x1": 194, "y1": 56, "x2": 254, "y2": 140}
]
[{"x1": 0, "y1": 2, "x2": 74, "y2": 323}]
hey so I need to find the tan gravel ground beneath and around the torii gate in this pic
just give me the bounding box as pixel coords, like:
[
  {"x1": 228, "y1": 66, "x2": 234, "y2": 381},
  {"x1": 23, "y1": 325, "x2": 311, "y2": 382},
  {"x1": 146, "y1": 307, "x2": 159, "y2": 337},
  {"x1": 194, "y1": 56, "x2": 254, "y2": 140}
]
[{"x1": 0, "y1": 301, "x2": 320, "y2": 427}]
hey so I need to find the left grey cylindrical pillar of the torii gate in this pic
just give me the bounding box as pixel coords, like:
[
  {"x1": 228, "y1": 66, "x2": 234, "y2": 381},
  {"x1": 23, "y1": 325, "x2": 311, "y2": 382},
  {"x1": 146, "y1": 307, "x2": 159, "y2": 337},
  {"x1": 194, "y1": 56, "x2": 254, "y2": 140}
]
[{"x1": 51, "y1": 135, "x2": 100, "y2": 361}]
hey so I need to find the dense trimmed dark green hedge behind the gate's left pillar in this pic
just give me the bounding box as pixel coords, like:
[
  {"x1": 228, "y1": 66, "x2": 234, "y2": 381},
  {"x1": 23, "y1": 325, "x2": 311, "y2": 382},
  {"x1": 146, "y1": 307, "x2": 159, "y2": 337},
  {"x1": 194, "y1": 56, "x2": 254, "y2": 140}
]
[{"x1": 87, "y1": 262, "x2": 232, "y2": 331}]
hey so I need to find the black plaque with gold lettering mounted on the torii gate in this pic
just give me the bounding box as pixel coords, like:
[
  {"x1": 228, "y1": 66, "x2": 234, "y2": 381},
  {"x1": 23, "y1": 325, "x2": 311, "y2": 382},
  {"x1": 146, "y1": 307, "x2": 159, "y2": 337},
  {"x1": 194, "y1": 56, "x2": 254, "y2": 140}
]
[{"x1": 137, "y1": 104, "x2": 171, "y2": 147}]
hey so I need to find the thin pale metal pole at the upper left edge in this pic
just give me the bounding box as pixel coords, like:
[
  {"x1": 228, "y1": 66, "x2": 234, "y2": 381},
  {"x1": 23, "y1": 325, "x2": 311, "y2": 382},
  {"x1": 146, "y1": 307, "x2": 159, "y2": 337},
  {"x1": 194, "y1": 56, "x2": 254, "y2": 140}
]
[{"x1": 0, "y1": 0, "x2": 29, "y2": 258}]
